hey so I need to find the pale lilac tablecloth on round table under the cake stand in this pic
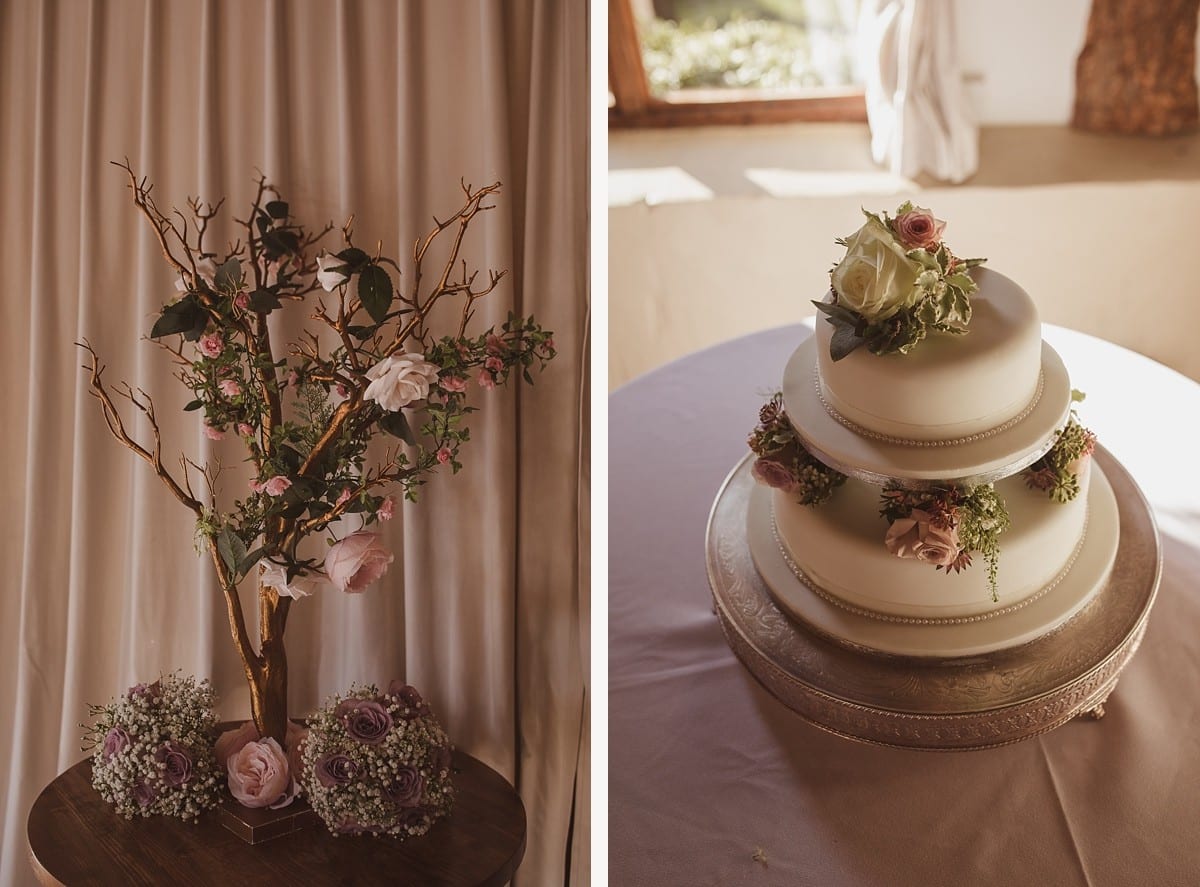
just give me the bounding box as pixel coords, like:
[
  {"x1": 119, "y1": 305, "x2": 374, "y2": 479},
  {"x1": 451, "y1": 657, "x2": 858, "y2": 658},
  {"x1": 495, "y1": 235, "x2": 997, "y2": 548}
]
[{"x1": 608, "y1": 326, "x2": 1200, "y2": 887}]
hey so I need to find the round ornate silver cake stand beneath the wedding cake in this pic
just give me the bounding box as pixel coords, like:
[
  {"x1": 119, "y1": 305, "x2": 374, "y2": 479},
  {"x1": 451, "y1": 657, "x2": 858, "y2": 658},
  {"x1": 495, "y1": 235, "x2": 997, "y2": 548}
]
[{"x1": 706, "y1": 448, "x2": 1162, "y2": 750}]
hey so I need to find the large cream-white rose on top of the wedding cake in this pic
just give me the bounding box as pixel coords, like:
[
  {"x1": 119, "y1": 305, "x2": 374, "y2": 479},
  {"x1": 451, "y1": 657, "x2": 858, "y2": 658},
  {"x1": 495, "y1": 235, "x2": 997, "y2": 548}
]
[{"x1": 833, "y1": 218, "x2": 920, "y2": 320}]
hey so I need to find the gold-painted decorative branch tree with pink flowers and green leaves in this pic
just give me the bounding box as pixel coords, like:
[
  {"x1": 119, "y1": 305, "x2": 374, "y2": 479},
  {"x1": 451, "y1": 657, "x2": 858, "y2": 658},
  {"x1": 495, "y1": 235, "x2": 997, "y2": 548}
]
[{"x1": 79, "y1": 161, "x2": 554, "y2": 747}]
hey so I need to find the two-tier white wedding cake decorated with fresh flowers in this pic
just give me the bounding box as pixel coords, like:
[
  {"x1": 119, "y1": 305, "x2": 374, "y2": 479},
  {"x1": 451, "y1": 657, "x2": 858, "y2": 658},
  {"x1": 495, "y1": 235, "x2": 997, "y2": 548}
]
[{"x1": 748, "y1": 204, "x2": 1120, "y2": 658}]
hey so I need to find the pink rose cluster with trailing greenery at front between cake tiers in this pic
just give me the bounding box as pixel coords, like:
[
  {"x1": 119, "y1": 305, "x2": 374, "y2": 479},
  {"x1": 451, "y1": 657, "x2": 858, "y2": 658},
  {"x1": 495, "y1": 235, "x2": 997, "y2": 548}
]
[{"x1": 880, "y1": 484, "x2": 1012, "y2": 600}]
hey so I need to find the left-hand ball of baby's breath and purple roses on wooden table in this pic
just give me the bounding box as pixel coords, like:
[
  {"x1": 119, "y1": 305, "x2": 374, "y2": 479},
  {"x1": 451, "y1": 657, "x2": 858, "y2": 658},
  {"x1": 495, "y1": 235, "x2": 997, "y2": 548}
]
[{"x1": 83, "y1": 672, "x2": 224, "y2": 820}]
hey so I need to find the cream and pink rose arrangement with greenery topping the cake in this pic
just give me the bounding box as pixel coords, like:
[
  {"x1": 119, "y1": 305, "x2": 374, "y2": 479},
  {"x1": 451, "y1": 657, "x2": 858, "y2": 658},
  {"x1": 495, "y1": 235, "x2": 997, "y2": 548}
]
[{"x1": 812, "y1": 200, "x2": 986, "y2": 360}]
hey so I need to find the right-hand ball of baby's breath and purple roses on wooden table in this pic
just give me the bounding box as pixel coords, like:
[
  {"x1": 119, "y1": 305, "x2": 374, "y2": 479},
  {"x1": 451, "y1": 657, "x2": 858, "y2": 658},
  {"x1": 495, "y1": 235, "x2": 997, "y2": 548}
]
[{"x1": 301, "y1": 681, "x2": 454, "y2": 838}]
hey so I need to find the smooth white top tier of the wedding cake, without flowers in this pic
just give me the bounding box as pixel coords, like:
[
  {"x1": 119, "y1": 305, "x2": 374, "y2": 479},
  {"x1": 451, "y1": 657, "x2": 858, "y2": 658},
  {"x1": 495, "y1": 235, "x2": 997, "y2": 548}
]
[{"x1": 816, "y1": 268, "x2": 1042, "y2": 440}]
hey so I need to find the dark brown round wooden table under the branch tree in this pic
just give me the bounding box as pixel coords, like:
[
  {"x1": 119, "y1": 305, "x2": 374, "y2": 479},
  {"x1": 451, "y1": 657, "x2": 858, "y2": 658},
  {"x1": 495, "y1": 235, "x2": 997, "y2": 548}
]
[{"x1": 29, "y1": 751, "x2": 526, "y2": 887}]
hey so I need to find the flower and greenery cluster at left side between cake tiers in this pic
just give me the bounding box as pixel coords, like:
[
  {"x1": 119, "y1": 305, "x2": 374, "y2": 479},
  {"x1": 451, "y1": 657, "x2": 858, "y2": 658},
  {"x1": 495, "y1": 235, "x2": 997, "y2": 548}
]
[{"x1": 748, "y1": 392, "x2": 846, "y2": 505}]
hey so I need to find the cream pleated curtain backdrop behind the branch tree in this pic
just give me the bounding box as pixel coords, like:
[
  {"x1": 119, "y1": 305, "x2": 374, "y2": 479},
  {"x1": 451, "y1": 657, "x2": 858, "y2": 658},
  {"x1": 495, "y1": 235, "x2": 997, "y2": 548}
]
[{"x1": 0, "y1": 0, "x2": 589, "y2": 885}]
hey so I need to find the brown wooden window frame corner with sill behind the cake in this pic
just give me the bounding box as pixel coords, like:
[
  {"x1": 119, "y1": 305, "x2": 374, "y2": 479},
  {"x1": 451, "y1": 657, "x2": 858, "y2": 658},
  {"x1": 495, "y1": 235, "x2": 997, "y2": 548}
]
[{"x1": 608, "y1": 0, "x2": 866, "y2": 128}]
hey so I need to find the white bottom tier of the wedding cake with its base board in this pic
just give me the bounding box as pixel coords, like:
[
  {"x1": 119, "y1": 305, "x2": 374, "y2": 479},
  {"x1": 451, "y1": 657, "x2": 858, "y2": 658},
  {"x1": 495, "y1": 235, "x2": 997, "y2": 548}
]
[{"x1": 748, "y1": 466, "x2": 1120, "y2": 657}]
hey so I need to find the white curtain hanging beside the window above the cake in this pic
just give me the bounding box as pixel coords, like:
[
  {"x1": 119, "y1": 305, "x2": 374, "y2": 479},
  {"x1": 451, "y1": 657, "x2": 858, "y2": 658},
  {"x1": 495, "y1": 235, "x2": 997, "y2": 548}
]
[{"x1": 858, "y1": 0, "x2": 979, "y2": 184}]
